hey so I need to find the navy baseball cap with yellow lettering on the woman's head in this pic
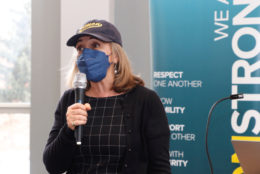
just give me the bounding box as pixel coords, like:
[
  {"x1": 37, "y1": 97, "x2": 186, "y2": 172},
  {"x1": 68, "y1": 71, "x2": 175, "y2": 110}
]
[{"x1": 67, "y1": 19, "x2": 122, "y2": 47}]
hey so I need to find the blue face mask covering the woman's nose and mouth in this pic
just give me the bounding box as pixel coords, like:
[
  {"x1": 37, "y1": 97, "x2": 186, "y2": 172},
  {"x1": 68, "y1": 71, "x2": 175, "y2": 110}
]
[{"x1": 77, "y1": 48, "x2": 110, "y2": 82}]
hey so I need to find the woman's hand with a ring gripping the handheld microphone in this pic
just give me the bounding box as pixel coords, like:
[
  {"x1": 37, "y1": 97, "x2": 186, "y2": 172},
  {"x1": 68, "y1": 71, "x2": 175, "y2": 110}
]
[{"x1": 66, "y1": 103, "x2": 91, "y2": 130}]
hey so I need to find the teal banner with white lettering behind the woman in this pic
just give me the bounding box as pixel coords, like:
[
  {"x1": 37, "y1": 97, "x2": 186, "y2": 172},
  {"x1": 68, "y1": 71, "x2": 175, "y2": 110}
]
[{"x1": 150, "y1": 0, "x2": 260, "y2": 174}]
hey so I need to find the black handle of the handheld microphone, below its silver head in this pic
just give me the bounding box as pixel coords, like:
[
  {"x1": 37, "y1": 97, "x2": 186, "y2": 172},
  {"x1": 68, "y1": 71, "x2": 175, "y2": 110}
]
[{"x1": 74, "y1": 88, "x2": 85, "y2": 145}]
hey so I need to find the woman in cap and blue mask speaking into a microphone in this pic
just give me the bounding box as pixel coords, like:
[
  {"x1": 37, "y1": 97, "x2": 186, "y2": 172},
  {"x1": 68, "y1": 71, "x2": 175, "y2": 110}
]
[{"x1": 43, "y1": 20, "x2": 171, "y2": 174}]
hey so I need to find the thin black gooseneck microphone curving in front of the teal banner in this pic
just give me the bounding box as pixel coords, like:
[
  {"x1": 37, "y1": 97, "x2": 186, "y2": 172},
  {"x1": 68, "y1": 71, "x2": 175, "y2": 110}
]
[{"x1": 205, "y1": 94, "x2": 244, "y2": 174}]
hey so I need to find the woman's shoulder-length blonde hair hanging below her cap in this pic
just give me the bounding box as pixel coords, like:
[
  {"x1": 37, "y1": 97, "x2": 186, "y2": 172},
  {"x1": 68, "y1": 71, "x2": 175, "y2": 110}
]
[{"x1": 67, "y1": 42, "x2": 144, "y2": 93}]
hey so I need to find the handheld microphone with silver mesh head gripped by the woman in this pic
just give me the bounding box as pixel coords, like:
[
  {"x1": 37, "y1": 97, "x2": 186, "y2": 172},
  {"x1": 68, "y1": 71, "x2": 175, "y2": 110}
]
[{"x1": 74, "y1": 73, "x2": 87, "y2": 145}]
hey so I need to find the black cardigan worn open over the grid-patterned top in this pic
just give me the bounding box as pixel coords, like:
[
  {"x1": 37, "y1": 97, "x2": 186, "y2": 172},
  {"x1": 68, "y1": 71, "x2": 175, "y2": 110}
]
[{"x1": 43, "y1": 86, "x2": 171, "y2": 174}]
